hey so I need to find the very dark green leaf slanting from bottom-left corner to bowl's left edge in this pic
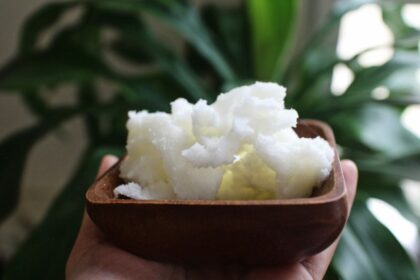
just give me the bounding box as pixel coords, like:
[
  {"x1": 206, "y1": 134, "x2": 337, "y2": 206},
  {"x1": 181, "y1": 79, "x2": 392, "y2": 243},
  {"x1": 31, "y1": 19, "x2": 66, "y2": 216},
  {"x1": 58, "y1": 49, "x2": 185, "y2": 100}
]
[{"x1": 3, "y1": 148, "x2": 122, "y2": 279}]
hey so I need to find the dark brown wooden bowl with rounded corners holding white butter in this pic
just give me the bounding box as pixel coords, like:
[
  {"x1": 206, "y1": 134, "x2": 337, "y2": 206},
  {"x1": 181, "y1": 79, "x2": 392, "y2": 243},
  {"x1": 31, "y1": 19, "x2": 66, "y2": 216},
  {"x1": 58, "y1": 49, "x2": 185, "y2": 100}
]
[{"x1": 86, "y1": 120, "x2": 347, "y2": 265}]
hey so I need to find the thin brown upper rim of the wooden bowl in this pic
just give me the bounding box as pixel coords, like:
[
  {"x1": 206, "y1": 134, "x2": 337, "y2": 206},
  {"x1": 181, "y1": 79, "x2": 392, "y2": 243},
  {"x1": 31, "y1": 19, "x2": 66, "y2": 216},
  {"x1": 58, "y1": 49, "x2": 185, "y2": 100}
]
[{"x1": 85, "y1": 119, "x2": 347, "y2": 206}]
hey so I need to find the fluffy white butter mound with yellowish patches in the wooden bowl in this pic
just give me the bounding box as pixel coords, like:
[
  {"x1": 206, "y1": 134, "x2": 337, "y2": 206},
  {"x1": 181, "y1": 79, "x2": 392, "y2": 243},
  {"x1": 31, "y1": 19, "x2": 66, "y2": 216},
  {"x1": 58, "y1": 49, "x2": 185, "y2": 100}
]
[{"x1": 114, "y1": 82, "x2": 334, "y2": 199}]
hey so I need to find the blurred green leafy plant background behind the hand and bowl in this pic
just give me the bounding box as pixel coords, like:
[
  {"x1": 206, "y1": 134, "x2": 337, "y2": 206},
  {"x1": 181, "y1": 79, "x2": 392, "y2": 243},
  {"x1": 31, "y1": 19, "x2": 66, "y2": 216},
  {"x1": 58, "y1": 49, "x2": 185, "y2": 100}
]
[{"x1": 0, "y1": 0, "x2": 420, "y2": 279}]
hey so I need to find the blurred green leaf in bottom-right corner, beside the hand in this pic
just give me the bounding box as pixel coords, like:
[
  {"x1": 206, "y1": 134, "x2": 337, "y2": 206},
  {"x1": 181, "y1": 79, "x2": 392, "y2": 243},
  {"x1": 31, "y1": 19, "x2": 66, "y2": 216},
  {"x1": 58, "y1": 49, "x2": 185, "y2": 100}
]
[{"x1": 334, "y1": 197, "x2": 420, "y2": 280}]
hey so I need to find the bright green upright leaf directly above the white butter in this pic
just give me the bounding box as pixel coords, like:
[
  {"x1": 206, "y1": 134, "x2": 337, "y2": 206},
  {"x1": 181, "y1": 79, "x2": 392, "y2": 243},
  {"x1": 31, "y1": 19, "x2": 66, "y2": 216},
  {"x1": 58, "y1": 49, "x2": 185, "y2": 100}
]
[{"x1": 247, "y1": 0, "x2": 298, "y2": 80}]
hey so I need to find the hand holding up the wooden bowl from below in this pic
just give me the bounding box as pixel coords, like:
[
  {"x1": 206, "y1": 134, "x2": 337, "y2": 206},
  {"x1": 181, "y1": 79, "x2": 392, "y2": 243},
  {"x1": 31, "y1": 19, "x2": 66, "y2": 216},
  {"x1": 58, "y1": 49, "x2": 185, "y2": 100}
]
[{"x1": 66, "y1": 156, "x2": 358, "y2": 280}]
